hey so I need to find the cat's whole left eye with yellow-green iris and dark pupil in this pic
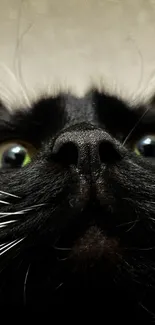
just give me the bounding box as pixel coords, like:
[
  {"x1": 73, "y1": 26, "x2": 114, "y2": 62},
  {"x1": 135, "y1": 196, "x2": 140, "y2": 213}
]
[{"x1": 0, "y1": 142, "x2": 36, "y2": 168}]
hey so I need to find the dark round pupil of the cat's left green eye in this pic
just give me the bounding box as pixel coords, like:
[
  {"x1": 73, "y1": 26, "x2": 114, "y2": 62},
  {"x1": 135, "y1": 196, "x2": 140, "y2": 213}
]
[{"x1": 1, "y1": 144, "x2": 27, "y2": 168}]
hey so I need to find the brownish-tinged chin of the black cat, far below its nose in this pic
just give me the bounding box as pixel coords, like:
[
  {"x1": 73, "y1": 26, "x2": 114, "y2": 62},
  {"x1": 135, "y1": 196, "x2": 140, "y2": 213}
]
[{"x1": 50, "y1": 226, "x2": 122, "y2": 272}]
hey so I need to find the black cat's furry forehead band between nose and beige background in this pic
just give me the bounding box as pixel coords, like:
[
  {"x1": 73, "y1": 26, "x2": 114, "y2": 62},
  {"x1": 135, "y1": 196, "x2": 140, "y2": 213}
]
[{"x1": 0, "y1": 90, "x2": 155, "y2": 143}]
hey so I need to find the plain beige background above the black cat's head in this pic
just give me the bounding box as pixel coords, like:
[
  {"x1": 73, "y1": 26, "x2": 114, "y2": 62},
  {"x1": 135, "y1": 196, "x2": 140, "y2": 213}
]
[{"x1": 0, "y1": 0, "x2": 155, "y2": 106}]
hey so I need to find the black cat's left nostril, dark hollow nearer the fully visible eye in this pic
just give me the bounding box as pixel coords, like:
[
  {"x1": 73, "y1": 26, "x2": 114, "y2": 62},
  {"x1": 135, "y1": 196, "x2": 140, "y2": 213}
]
[{"x1": 54, "y1": 142, "x2": 78, "y2": 166}]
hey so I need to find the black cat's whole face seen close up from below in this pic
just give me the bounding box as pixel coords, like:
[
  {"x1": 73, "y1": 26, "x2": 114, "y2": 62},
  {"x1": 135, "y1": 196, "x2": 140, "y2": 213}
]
[{"x1": 0, "y1": 91, "x2": 155, "y2": 321}]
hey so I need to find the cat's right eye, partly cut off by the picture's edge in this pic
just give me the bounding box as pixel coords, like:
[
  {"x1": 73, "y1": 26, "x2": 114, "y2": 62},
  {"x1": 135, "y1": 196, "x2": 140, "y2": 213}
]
[{"x1": 134, "y1": 135, "x2": 155, "y2": 159}]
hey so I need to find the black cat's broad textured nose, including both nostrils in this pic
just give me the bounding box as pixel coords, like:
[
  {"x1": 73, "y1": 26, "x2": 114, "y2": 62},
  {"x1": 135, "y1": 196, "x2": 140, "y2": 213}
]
[{"x1": 53, "y1": 127, "x2": 121, "y2": 173}]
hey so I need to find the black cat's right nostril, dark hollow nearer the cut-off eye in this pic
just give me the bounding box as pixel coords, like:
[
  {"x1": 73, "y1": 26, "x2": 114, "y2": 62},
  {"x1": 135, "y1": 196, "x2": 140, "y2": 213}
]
[{"x1": 98, "y1": 141, "x2": 121, "y2": 163}]
